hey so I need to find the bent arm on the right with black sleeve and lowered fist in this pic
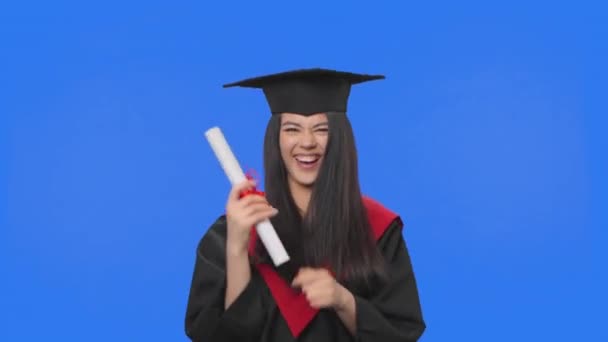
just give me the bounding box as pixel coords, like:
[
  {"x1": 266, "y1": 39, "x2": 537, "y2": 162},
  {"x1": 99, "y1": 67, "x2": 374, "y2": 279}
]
[{"x1": 292, "y1": 220, "x2": 426, "y2": 342}]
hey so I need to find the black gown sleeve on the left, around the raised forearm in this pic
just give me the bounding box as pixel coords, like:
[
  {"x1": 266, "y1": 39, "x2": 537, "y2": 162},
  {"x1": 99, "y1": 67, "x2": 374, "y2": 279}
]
[{"x1": 185, "y1": 216, "x2": 266, "y2": 342}]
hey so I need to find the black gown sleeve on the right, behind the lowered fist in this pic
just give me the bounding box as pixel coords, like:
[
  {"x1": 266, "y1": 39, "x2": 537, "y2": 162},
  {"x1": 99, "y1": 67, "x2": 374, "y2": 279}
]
[{"x1": 355, "y1": 220, "x2": 426, "y2": 342}]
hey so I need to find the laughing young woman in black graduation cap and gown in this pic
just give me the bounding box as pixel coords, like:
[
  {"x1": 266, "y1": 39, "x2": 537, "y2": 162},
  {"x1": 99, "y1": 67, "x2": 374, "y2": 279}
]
[{"x1": 185, "y1": 69, "x2": 426, "y2": 342}]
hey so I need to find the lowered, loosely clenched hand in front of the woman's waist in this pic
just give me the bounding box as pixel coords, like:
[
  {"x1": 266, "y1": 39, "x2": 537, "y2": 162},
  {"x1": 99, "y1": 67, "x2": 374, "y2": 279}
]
[{"x1": 292, "y1": 267, "x2": 352, "y2": 311}]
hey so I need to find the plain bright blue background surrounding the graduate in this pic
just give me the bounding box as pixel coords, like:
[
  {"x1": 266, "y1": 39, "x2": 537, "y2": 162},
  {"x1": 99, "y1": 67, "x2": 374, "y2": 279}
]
[{"x1": 0, "y1": 1, "x2": 608, "y2": 341}]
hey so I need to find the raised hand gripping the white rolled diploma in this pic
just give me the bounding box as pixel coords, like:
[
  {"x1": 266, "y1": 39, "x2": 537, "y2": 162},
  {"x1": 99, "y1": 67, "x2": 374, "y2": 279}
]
[{"x1": 226, "y1": 180, "x2": 278, "y2": 253}]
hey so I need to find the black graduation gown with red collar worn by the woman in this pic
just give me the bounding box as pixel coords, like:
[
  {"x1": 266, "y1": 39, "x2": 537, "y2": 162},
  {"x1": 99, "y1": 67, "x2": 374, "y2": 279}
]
[{"x1": 185, "y1": 198, "x2": 426, "y2": 342}]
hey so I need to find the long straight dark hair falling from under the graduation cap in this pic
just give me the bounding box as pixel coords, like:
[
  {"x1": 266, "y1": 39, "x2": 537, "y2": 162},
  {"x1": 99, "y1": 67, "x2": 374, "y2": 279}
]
[{"x1": 256, "y1": 112, "x2": 384, "y2": 289}]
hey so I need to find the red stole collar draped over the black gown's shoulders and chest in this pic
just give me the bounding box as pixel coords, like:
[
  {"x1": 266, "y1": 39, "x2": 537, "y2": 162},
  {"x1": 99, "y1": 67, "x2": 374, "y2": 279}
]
[{"x1": 249, "y1": 196, "x2": 397, "y2": 337}]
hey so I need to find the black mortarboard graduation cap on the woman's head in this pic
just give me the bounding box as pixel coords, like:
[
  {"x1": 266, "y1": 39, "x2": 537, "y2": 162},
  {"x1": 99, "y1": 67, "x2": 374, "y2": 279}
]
[{"x1": 224, "y1": 68, "x2": 385, "y2": 115}]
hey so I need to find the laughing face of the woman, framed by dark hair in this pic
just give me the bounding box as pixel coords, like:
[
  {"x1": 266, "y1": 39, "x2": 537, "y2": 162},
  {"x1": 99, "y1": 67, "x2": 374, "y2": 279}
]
[{"x1": 279, "y1": 113, "x2": 329, "y2": 187}]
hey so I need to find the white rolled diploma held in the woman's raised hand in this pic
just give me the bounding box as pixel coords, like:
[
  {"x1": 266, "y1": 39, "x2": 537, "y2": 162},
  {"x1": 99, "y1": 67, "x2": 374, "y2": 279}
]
[{"x1": 205, "y1": 127, "x2": 289, "y2": 266}]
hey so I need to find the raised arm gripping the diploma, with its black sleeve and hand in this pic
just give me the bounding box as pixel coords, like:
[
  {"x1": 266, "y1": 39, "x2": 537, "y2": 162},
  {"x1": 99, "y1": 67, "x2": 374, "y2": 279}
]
[{"x1": 185, "y1": 183, "x2": 276, "y2": 341}]
